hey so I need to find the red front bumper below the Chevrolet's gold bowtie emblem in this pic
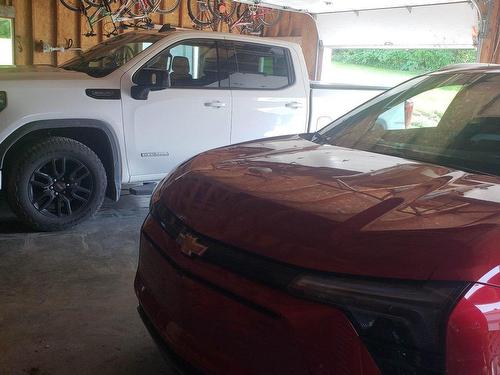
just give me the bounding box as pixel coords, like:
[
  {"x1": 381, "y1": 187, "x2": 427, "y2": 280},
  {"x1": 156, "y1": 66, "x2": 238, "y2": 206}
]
[{"x1": 135, "y1": 217, "x2": 379, "y2": 375}]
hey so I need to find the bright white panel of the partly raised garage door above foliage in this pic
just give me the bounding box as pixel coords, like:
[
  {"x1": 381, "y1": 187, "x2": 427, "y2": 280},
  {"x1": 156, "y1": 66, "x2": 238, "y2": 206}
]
[{"x1": 316, "y1": 3, "x2": 478, "y2": 48}]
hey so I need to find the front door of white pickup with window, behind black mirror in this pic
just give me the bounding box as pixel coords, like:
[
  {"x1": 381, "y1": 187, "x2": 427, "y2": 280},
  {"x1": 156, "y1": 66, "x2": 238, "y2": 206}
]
[{"x1": 121, "y1": 39, "x2": 231, "y2": 181}]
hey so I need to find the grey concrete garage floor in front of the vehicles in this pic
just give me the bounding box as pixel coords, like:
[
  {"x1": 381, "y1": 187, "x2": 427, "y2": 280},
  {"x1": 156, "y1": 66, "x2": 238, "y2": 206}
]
[{"x1": 0, "y1": 195, "x2": 178, "y2": 375}]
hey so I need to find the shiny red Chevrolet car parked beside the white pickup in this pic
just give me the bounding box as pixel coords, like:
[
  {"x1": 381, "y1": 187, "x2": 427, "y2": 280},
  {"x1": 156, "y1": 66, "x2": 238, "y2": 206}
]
[{"x1": 135, "y1": 65, "x2": 500, "y2": 375}]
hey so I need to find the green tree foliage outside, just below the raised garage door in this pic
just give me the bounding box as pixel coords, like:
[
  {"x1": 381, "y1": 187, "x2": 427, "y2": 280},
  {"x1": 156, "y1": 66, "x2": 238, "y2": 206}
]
[{"x1": 333, "y1": 49, "x2": 476, "y2": 73}]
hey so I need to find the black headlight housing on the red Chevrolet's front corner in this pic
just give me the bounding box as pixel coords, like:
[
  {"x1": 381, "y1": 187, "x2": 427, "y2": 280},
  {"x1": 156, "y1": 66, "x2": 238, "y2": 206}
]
[{"x1": 289, "y1": 275, "x2": 470, "y2": 375}]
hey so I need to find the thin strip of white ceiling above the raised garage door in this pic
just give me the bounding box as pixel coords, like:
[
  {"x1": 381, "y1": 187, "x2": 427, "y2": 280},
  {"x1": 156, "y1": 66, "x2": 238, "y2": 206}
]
[{"x1": 244, "y1": 0, "x2": 470, "y2": 14}]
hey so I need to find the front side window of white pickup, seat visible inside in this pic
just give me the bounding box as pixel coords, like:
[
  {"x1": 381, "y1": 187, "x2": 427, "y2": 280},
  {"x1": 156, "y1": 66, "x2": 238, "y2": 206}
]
[{"x1": 141, "y1": 39, "x2": 219, "y2": 88}]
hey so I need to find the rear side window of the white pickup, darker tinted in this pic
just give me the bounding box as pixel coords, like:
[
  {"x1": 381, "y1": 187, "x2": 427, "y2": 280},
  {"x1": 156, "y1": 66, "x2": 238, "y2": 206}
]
[{"x1": 221, "y1": 42, "x2": 293, "y2": 90}]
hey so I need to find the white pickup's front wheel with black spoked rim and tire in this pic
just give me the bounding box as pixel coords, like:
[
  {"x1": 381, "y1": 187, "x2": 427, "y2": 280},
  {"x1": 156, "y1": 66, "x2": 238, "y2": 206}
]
[{"x1": 7, "y1": 137, "x2": 107, "y2": 232}]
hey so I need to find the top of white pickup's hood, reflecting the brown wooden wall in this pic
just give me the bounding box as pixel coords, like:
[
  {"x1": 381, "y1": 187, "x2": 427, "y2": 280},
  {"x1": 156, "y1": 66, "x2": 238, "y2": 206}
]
[{"x1": 0, "y1": 65, "x2": 92, "y2": 81}]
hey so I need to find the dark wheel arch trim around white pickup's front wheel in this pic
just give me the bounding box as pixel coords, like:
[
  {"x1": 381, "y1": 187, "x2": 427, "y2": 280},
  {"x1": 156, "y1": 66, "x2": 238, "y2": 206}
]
[{"x1": 0, "y1": 119, "x2": 122, "y2": 201}]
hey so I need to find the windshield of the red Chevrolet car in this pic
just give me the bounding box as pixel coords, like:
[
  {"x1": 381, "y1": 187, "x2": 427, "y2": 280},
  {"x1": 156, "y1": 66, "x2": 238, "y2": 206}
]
[{"x1": 313, "y1": 73, "x2": 500, "y2": 176}]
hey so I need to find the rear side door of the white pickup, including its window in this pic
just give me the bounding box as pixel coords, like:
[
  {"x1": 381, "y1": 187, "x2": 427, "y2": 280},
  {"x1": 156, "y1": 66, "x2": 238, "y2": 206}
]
[{"x1": 224, "y1": 41, "x2": 309, "y2": 143}]
